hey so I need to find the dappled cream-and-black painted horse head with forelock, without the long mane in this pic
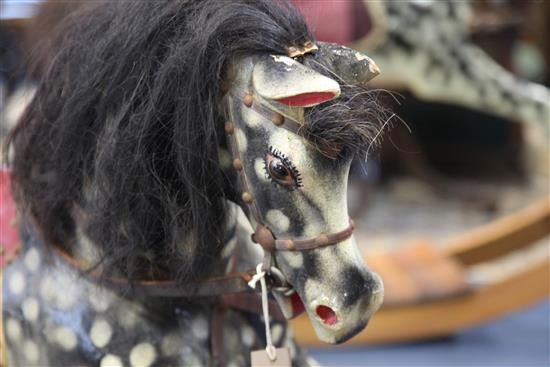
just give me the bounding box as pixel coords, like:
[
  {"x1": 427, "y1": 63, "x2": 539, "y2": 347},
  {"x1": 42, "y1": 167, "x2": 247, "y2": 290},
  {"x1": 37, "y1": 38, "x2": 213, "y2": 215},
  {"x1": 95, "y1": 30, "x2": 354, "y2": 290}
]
[{"x1": 224, "y1": 46, "x2": 383, "y2": 343}]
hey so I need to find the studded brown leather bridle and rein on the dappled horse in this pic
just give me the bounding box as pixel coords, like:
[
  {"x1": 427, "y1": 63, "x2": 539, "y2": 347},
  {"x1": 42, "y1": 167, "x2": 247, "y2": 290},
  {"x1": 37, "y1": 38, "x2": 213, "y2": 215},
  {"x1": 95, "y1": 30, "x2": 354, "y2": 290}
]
[{"x1": 47, "y1": 88, "x2": 354, "y2": 298}]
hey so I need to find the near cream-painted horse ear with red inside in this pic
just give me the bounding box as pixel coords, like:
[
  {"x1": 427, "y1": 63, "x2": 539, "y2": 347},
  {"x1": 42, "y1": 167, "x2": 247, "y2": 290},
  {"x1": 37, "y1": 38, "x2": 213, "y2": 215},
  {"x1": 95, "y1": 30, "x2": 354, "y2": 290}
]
[{"x1": 252, "y1": 55, "x2": 340, "y2": 107}]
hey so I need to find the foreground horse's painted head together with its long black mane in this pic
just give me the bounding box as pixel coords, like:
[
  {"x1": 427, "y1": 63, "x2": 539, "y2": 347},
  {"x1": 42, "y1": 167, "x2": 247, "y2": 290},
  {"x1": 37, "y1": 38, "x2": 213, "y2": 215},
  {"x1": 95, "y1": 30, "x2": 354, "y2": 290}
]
[{"x1": 11, "y1": 0, "x2": 384, "y2": 350}]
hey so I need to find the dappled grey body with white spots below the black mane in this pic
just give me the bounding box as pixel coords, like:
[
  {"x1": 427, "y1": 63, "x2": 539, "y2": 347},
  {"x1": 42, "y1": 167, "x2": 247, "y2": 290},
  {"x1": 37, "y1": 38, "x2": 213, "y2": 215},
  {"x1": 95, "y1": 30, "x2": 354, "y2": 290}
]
[{"x1": 4, "y1": 220, "x2": 307, "y2": 367}]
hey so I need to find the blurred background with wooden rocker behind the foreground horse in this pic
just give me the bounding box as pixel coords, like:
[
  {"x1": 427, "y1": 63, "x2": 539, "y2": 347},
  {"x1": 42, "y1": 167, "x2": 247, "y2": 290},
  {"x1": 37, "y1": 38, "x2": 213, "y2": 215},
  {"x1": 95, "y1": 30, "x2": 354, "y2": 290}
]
[{"x1": 0, "y1": 0, "x2": 550, "y2": 366}]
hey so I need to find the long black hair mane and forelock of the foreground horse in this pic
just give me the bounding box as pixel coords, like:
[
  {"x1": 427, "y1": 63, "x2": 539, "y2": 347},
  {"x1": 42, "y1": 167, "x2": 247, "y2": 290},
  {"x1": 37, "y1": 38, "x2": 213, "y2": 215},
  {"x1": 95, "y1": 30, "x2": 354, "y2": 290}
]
[{"x1": 10, "y1": 0, "x2": 388, "y2": 282}]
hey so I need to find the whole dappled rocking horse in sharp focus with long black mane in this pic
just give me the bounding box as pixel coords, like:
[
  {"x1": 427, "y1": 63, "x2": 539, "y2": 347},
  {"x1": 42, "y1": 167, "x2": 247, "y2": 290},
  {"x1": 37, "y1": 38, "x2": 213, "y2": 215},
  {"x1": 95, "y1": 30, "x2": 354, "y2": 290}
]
[{"x1": 3, "y1": 0, "x2": 391, "y2": 367}]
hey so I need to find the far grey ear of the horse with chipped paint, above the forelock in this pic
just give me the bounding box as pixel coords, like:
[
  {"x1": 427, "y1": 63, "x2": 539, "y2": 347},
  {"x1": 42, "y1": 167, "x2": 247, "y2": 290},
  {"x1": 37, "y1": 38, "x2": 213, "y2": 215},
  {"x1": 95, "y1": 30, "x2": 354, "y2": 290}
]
[{"x1": 318, "y1": 42, "x2": 380, "y2": 86}]
